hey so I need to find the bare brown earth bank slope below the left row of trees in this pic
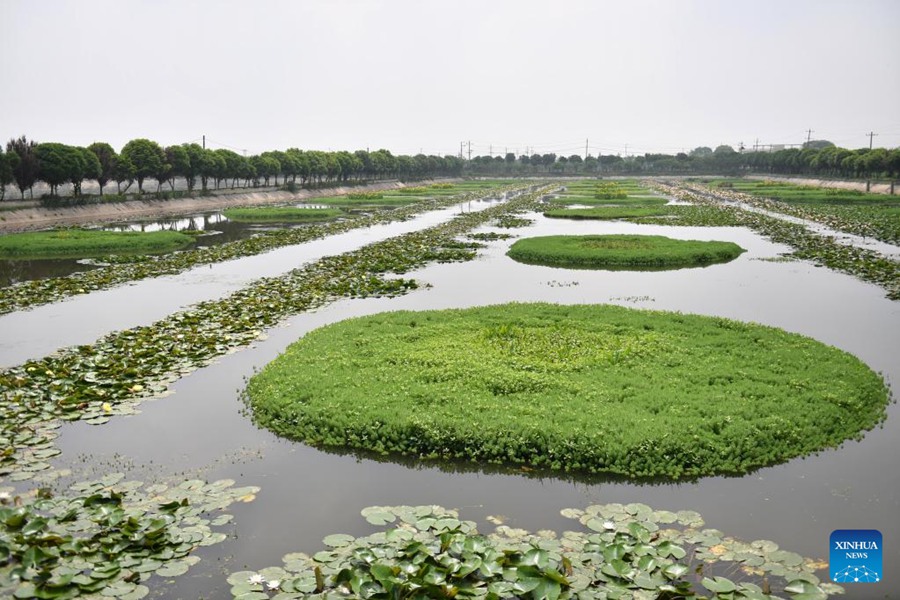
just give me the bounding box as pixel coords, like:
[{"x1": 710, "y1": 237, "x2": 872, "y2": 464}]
[{"x1": 0, "y1": 181, "x2": 414, "y2": 233}]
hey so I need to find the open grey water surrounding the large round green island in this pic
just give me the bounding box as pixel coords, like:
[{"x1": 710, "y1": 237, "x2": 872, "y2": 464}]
[{"x1": 42, "y1": 215, "x2": 900, "y2": 598}]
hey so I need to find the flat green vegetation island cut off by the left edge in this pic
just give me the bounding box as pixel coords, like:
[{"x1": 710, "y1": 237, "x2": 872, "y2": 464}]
[{"x1": 0, "y1": 229, "x2": 194, "y2": 259}]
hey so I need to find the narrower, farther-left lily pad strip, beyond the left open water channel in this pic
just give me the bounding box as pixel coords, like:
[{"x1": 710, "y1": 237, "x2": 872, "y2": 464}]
[{"x1": 0, "y1": 184, "x2": 525, "y2": 314}]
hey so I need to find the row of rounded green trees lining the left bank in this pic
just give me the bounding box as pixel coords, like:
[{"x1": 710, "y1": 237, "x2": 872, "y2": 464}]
[{"x1": 0, "y1": 136, "x2": 464, "y2": 199}]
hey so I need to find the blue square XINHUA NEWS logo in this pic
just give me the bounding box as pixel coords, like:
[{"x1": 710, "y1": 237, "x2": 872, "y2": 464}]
[{"x1": 828, "y1": 529, "x2": 883, "y2": 583}]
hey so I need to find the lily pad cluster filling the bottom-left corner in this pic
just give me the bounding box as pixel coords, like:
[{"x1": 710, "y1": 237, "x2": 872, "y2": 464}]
[{"x1": 0, "y1": 473, "x2": 259, "y2": 600}]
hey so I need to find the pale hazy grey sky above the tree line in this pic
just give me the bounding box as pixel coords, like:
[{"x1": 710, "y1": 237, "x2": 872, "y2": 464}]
[{"x1": 0, "y1": 0, "x2": 900, "y2": 156}]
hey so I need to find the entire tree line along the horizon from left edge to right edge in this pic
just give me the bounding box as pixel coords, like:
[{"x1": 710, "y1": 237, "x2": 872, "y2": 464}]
[{"x1": 0, "y1": 136, "x2": 900, "y2": 199}]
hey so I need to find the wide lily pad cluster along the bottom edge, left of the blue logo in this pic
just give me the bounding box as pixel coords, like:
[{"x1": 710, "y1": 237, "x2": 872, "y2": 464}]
[{"x1": 228, "y1": 504, "x2": 843, "y2": 600}]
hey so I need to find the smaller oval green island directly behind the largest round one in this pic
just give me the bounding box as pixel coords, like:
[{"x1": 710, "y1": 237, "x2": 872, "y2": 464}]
[{"x1": 506, "y1": 234, "x2": 745, "y2": 269}]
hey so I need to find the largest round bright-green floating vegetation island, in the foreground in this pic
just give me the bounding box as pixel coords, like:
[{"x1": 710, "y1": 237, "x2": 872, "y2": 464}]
[{"x1": 247, "y1": 304, "x2": 888, "y2": 479}]
